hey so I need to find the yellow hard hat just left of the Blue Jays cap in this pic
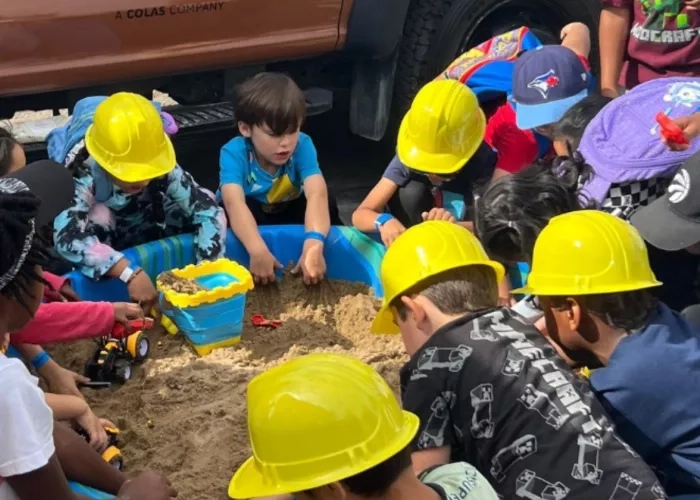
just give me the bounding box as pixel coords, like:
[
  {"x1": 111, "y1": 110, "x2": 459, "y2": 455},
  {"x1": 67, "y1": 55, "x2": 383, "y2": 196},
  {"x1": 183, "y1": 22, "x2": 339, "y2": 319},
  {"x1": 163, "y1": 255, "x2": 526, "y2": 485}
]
[{"x1": 396, "y1": 80, "x2": 486, "y2": 175}]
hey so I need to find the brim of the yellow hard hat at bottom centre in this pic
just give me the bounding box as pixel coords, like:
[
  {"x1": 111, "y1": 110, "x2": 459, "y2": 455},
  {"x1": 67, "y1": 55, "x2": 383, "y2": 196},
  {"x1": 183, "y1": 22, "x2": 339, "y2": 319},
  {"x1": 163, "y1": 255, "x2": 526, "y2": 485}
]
[{"x1": 228, "y1": 410, "x2": 420, "y2": 499}]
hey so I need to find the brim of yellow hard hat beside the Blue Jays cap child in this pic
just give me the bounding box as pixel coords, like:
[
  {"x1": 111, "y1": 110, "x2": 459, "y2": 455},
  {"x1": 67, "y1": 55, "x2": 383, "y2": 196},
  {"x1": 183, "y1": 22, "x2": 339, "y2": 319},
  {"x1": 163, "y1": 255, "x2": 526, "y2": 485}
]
[{"x1": 396, "y1": 109, "x2": 486, "y2": 175}]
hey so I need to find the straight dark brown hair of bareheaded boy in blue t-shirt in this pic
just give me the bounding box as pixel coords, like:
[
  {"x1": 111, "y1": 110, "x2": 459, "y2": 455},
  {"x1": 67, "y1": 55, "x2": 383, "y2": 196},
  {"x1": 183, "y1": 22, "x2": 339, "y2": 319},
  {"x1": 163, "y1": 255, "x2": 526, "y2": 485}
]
[{"x1": 233, "y1": 73, "x2": 306, "y2": 135}]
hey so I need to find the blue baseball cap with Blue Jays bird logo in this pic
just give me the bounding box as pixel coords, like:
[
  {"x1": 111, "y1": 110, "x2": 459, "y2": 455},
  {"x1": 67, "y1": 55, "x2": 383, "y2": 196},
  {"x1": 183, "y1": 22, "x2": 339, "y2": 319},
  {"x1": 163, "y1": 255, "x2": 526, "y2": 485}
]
[{"x1": 512, "y1": 45, "x2": 591, "y2": 130}]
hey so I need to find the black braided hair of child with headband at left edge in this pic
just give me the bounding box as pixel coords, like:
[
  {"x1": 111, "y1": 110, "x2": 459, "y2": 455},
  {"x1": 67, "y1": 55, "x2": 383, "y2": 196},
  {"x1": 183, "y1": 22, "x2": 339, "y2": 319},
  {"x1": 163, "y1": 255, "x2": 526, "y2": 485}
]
[{"x1": 0, "y1": 191, "x2": 50, "y2": 315}]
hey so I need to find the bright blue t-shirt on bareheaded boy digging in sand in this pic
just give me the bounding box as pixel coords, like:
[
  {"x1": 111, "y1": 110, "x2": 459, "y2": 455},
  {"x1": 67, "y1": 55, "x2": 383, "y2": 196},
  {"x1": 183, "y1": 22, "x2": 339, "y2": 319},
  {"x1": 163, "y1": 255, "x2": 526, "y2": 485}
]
[{"x1": 217, "y1": 133, "x2": 321, "y2": 205}]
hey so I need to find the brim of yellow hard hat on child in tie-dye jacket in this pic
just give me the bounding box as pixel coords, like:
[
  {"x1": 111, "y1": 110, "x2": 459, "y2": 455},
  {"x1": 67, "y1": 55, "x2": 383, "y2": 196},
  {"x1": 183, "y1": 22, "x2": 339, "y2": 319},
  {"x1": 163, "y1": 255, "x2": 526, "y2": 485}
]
[{"x1": 85, "y1": 125, "x2": 177, "y2": 183}]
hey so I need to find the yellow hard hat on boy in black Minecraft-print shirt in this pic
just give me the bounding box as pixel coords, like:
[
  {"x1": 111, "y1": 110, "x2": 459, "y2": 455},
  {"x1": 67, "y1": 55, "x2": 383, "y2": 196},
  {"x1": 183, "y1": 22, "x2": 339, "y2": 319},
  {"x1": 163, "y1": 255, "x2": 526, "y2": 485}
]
[{"x1": 372, "y1": 221, "x2": 505, "y2": 333}]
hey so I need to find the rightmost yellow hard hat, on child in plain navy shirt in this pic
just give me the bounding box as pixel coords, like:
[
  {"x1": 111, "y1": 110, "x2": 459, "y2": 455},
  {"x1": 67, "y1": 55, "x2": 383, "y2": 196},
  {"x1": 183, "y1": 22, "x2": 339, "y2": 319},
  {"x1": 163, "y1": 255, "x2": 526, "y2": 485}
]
[{"x1": 512, "y1": 210, "x2": 662, "y2": 297}]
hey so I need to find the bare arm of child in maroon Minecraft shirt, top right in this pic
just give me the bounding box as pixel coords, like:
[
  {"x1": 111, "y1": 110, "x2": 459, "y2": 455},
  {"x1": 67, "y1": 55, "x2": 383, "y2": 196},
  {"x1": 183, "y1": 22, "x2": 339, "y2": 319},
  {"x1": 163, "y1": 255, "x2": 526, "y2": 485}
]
[{"x1": 598, "y1": 0, "x2": 632, "y2": 97}]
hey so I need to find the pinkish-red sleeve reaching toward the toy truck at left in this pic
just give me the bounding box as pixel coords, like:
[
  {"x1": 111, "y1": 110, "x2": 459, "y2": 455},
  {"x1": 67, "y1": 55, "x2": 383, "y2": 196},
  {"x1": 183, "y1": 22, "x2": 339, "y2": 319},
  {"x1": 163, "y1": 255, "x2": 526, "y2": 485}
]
[{"x1": 10, "y1": 302, "x2": 116, "y2": 345}]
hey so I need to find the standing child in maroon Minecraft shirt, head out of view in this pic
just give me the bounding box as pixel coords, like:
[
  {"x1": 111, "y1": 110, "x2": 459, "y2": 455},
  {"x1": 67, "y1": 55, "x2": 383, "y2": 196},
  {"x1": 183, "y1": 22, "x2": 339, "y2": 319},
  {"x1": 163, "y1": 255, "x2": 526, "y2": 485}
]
[{"x1": 599, "y1": 0, "x2": 700, "y2": 97}]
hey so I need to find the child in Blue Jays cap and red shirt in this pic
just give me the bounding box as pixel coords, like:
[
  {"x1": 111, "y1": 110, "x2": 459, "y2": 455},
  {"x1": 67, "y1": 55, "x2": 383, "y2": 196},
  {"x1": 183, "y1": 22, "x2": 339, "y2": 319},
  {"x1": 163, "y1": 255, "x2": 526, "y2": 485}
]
[{"x1": 438, "y1": 23, "x2": 593, "y2": 179}]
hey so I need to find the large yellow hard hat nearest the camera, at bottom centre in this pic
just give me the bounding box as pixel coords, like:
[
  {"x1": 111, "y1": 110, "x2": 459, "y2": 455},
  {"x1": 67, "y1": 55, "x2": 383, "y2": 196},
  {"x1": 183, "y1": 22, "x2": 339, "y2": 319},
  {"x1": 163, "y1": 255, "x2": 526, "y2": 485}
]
[{"x1": 228, "y1": 353, "x2": 419, "y2": 498}]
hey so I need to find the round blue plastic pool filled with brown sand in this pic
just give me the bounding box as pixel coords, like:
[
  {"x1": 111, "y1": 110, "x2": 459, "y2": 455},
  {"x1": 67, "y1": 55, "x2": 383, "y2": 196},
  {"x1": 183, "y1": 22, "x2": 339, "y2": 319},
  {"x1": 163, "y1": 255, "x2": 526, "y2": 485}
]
[{"x1": 51, "y1": 226, "x2": 406, "y2": 500}]
